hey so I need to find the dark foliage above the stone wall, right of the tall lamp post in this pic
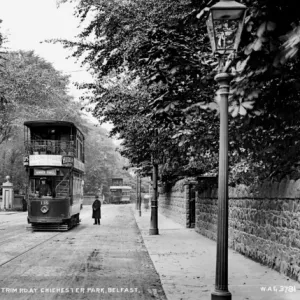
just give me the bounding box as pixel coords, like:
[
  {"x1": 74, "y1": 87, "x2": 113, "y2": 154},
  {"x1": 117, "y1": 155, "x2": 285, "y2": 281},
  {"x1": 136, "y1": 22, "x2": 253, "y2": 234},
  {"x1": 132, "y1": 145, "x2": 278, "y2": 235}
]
[{"x1": 220, "y1": 0, "x2": 300, "y2": 182}]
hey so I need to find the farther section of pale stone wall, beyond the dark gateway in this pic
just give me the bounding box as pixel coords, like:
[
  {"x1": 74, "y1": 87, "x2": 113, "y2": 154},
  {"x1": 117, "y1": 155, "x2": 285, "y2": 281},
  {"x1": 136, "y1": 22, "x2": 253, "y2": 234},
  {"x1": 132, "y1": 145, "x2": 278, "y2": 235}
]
[{"x1": 158, "y1": 180, "x2": 189, "y2": 227}]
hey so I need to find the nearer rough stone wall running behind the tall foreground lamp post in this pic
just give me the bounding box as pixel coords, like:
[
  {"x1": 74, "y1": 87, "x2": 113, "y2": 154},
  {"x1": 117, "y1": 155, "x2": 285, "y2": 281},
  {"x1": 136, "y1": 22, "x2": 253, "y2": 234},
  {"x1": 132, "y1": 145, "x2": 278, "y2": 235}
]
[{"x1": 195, "y1": 180, "x2": 300, "y2": 282}]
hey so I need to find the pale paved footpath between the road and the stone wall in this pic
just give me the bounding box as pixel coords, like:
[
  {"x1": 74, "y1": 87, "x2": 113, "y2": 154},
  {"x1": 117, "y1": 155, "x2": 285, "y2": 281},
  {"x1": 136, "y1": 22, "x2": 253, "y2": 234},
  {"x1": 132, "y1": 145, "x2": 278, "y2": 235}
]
[{"x1": 132, "y1": 206, "x2": 300, "y2": 300}]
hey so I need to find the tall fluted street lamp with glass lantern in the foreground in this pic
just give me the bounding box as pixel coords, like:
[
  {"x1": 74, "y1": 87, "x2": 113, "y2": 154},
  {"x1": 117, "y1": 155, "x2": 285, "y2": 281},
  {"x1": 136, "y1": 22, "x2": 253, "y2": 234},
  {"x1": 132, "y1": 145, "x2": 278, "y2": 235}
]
[{"x1": 207, "y1": 0, "x2": 247, "y2": 300}]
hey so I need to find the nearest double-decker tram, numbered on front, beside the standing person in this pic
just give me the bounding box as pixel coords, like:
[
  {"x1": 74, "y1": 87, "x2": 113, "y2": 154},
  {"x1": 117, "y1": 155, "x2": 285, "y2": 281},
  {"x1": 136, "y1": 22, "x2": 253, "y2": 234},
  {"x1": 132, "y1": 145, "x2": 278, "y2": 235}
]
[{"x1": 24, "y1": 121, "x2": 84, "y2": 231}]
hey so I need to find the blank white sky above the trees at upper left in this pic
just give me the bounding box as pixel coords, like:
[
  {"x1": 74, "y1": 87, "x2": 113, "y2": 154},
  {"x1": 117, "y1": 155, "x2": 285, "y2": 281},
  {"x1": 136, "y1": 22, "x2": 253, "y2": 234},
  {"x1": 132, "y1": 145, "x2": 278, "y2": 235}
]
[{"x1": 0, "y1": 0, "x2": 113, "y2": 129}]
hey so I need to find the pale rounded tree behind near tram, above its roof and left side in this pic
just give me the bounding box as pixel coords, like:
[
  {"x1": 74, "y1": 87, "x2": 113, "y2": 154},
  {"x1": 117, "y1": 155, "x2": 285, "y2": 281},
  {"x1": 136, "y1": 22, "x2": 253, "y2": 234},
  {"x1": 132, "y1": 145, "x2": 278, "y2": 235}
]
[{"x1": 0, "y1": 51, "x2": 79, "y2": 190}]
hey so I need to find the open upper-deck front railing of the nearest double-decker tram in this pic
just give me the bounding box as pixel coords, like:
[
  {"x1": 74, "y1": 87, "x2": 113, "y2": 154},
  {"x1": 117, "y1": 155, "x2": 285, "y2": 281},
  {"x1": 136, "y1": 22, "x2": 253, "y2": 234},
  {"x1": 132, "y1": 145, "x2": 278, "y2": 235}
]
[{"x1": 25, "y1": 140, "x2": 76, "y2": 156}]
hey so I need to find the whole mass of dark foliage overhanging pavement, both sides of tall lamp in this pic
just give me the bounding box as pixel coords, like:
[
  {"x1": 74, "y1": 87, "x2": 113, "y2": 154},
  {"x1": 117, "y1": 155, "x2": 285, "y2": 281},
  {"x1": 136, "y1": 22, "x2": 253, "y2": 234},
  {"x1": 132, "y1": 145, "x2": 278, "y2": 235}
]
[{"x1": 55, "y1": 0, "x2": 300, "y2": 183}]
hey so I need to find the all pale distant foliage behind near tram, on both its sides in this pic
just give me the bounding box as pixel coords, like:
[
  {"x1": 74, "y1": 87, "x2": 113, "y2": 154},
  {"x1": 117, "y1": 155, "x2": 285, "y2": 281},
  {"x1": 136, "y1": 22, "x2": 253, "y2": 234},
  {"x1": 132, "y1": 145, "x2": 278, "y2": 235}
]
[{"x1": 0, "y1": 51, "x2": 127, "y2": 193}]
